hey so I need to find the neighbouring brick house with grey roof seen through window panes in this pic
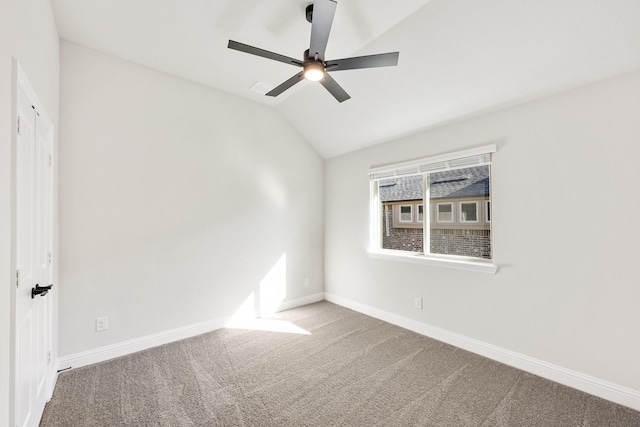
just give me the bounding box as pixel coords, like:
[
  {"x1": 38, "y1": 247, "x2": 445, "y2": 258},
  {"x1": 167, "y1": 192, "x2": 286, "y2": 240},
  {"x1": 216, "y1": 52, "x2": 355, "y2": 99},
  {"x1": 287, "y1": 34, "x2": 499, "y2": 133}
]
[{"x1": 378, "y1": 166, "x2": 491, "y2": 259}]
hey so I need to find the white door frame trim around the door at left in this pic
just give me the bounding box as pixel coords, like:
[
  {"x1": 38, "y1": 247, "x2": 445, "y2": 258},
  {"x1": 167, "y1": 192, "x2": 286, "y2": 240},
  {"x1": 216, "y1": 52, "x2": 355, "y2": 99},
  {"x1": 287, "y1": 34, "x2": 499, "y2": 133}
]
[{"x1": 9, "y1": 58, "x2": 59, "y2": 425}]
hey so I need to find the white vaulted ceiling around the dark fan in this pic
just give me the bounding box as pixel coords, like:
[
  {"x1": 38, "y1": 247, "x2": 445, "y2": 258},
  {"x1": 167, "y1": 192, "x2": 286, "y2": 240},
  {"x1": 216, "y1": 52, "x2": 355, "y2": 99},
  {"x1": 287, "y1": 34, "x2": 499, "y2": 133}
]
[{"x1": 51, "y1": 0, "x2": 640, "y2": 158}]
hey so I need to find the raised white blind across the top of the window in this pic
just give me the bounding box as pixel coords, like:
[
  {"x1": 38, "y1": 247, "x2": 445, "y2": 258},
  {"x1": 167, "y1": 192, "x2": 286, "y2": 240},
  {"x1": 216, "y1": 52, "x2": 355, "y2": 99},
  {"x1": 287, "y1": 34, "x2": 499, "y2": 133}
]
[{"x1": 369, "y1": 144, "x2": 497, "y2": 179}]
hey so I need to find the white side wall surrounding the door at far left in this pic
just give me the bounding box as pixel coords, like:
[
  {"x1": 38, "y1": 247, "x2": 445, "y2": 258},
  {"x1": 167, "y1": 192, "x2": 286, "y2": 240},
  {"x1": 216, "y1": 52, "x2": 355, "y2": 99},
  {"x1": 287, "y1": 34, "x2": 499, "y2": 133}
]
[{"x1": 0, "y1": 0, "x2": 59, "y2": 425}]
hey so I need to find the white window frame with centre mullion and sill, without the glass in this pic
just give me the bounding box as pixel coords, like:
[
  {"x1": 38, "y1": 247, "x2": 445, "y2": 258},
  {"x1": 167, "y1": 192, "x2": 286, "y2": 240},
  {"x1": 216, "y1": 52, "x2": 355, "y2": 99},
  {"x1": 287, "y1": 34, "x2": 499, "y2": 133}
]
[{"x1": 367, "y1": 144, "x2": 498, "y2": 274}]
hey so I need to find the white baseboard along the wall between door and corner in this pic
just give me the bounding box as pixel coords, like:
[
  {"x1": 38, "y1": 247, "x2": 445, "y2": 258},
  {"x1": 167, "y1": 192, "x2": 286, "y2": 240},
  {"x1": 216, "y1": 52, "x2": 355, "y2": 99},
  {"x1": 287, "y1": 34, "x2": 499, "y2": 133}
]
[{"x1": 56, "y1": 293, "x2": 324, "y2": 372}]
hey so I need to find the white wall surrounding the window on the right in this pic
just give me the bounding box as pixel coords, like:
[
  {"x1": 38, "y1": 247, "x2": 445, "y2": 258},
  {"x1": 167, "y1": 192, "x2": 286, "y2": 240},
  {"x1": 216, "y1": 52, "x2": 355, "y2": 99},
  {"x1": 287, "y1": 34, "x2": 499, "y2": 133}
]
[{"x1": 325, "y1": 73, "x2": 640, "y2": 392}]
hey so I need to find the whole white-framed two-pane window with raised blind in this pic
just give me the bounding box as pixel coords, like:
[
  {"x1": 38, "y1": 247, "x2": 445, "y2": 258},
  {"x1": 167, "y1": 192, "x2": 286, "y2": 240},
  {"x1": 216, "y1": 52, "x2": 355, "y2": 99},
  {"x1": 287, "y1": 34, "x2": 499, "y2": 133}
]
[{"x1": 369, "y1": 145, "x2": 496, "y2": 272}]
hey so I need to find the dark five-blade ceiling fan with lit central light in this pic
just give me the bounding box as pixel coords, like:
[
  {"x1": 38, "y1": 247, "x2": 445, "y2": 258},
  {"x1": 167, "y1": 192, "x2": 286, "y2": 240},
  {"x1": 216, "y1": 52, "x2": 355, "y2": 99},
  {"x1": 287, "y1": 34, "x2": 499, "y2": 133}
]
[{"x1": 228, "y1": 0, "x2": 400, "y2": 102}]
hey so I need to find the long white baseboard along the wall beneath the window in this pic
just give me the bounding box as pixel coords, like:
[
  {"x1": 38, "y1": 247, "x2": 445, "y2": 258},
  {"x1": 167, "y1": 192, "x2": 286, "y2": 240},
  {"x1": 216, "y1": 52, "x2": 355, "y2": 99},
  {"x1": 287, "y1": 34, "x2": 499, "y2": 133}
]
[{"x1": 325, "y1": 293, "x2": 640, "y2": 411}]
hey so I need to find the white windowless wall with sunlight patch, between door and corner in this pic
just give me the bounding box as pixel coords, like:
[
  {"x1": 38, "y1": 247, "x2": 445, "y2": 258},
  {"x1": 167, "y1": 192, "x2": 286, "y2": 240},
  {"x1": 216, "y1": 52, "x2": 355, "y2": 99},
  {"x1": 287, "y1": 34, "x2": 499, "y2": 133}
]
[{"x1": 60, "y1": 42, "x2": 323, "y2": 356}]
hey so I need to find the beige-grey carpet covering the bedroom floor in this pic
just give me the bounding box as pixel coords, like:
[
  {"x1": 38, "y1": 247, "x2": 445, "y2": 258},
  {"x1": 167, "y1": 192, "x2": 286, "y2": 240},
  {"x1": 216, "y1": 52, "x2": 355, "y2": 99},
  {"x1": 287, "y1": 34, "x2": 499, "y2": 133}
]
[{"x1": 40, "y1": 302, "x2": 640, "y2": 427}]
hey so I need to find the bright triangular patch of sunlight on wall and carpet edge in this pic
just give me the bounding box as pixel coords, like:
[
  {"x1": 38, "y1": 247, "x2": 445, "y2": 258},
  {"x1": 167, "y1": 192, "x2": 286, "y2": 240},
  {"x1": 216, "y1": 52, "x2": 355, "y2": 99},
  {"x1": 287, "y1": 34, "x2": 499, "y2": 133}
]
[{"x1": 226, "y1": 253, "x2": 311, "y2": 335}]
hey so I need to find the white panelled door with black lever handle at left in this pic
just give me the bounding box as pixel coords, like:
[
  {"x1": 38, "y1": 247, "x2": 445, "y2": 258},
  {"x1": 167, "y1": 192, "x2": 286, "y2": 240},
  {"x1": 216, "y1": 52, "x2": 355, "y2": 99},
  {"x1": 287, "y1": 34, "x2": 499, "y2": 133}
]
[{"x1": 15, "y1": 84, "x2": 52, "y2": 427}]
